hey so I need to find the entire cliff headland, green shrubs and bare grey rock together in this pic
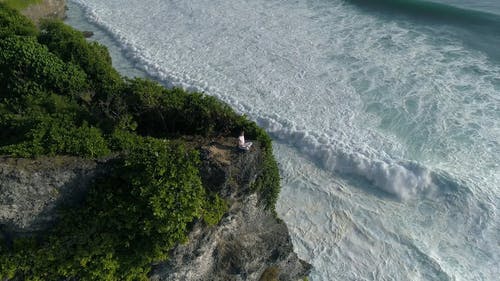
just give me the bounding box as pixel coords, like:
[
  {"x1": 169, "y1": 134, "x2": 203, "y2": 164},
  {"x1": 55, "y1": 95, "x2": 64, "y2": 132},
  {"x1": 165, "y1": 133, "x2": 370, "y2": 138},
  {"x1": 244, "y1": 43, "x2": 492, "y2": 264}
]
[{"x1": 0, "y1": 3, "x2": 311, "y2": 281}]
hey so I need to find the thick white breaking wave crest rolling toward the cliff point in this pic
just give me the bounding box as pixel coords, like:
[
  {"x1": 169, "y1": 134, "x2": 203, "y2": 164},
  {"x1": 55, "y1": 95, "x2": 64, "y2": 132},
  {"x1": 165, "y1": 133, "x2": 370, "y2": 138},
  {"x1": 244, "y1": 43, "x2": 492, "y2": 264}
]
[{"x1": 257, "y1": 114, "x2": 435, "y2": 200}]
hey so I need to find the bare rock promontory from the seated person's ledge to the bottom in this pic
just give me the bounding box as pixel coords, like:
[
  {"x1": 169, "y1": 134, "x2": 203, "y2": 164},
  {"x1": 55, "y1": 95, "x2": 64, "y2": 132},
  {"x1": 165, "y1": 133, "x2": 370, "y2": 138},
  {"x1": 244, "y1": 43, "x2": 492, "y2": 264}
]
[{"x1": 151, "y1": 142, "x2": 311, "y2": 281}]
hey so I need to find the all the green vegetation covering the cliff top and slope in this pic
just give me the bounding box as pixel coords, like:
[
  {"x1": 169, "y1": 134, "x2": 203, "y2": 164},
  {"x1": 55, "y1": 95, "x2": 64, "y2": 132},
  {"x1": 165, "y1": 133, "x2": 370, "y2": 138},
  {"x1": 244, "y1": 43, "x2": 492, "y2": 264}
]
[{"x1": 0, "y1": 3, "x2": 279, "y2": 280}]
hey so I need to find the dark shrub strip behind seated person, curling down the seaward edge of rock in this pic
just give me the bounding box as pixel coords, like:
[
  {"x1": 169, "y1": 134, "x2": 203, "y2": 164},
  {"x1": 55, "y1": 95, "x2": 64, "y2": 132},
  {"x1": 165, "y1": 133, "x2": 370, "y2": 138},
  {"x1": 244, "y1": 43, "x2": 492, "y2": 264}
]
[{"x1": 120, "y1": 79, "x2": 280, "y2": 210}]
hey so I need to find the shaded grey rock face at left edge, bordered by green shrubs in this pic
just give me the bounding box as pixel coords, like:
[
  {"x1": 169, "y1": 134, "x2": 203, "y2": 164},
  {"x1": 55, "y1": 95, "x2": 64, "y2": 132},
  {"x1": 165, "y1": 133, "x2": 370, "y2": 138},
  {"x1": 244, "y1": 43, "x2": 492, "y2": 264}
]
[{"x1": 0, "y1": 157, "x2": 106, "y2": 235}]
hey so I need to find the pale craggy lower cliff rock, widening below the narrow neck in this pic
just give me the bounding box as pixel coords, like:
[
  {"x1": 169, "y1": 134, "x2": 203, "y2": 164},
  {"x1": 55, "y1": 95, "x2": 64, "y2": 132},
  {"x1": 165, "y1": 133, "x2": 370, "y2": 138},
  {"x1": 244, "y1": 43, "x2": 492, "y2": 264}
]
[{"x1": 151, "y1": 194, "x2": 311, "y2": 281}]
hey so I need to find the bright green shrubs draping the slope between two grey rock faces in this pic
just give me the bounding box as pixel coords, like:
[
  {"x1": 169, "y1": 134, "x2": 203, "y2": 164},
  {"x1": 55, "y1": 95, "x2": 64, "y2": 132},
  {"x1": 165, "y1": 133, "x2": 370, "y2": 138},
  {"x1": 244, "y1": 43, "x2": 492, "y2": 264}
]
[{"x1": 0, "y1": 138, "x2": 207, "y2": 280}]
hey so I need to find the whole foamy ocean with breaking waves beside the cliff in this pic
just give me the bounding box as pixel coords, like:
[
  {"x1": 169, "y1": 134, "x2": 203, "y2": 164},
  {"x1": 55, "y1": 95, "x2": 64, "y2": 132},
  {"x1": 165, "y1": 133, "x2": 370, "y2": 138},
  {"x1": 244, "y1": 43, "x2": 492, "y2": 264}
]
[{"x1": 68, "y1": 0, "x2": 500, "y2": 281}]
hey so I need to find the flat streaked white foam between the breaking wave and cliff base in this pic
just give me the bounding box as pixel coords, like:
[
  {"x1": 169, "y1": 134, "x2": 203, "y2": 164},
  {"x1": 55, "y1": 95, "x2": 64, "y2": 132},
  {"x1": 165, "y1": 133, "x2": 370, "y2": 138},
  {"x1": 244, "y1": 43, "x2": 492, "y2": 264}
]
[{"x1": 275, "y1": 144, "x2": 498, "y2": 280}]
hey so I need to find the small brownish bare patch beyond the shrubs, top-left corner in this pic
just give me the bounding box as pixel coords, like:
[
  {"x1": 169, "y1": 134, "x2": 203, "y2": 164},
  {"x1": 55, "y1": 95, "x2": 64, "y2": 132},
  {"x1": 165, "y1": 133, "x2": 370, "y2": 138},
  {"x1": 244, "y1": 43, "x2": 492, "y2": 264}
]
[{"x1": 21, "y1": 0, "x2": 66, "y2": 23}]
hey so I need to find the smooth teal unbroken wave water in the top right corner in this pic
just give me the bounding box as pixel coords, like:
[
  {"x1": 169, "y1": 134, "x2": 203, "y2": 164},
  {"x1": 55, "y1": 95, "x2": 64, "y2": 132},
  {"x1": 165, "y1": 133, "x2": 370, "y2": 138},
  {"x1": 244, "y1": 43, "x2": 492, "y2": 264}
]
[{"x1": 346, "y1": 0, "x2": 500, "y2": 62}]
